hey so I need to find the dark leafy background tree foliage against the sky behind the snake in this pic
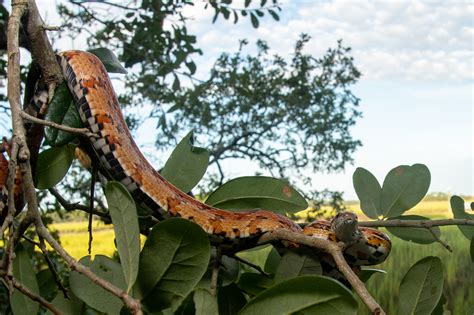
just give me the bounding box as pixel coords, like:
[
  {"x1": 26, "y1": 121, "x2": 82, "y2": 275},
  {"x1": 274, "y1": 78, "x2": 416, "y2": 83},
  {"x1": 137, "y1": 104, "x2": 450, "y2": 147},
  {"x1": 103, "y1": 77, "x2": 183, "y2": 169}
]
[{"x1": 53, "y1": 0, "x2": 361, "y2": 208}]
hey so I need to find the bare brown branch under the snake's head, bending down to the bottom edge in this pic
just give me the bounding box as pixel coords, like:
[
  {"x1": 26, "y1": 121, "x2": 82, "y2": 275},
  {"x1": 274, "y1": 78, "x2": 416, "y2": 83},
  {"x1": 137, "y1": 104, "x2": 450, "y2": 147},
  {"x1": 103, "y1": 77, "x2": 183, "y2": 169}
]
[{"x1": 258, "y1": 229, "x2": 385, "y2": 314}]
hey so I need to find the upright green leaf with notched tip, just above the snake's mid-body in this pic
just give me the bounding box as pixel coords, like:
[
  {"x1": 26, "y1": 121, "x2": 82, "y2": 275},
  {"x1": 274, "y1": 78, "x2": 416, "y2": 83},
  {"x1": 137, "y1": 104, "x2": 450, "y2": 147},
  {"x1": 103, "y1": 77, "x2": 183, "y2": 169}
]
[{"x1": 161, "y1": 131, "x2": 209, "y2": 191}]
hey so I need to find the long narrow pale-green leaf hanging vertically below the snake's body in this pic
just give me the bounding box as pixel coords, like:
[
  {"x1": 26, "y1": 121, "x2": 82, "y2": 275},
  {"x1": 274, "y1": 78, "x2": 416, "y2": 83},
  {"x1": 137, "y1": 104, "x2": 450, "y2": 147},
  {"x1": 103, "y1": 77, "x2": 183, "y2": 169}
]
[{"x1": 105, "y1": 181, "x2": 140, "y2": 292}]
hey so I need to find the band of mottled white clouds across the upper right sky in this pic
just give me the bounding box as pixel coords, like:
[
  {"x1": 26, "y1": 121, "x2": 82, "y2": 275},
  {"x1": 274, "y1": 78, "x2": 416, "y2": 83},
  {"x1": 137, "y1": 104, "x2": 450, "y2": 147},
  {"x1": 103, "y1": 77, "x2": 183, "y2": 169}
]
[{"x1": 186, "y1": 1, "x2": 474, "y2": 82}]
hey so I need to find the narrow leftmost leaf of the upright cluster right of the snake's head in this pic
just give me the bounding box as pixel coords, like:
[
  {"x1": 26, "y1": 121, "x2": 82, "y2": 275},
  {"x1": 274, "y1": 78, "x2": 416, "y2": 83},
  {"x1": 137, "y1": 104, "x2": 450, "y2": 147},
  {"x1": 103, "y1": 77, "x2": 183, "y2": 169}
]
[{"x1": 352, "y1": 167, "x2": 382, "y2": 219}]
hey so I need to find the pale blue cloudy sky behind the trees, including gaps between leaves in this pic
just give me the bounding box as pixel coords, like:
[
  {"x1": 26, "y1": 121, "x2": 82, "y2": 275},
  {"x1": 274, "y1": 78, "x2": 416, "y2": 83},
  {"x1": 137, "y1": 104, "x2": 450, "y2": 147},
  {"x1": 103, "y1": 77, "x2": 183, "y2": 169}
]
[{"x1": 15, "y1": 0, "x2": 474, "y2": 199}]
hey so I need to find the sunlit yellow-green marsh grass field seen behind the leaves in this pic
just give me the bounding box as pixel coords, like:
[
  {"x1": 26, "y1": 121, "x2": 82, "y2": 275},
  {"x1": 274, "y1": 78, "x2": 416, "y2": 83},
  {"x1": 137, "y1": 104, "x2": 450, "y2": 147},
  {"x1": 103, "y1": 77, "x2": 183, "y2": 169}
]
[{"x1": 50, "y1": 200, "x2": 474, "y2": 314}]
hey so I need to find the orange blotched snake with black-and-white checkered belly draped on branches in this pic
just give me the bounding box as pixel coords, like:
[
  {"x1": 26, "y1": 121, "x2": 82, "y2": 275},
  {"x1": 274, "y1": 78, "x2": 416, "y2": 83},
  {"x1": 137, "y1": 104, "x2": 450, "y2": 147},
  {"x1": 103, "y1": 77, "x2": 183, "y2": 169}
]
[{"x1": 1, "y1": 51, "x2": 391, "y2": 282}]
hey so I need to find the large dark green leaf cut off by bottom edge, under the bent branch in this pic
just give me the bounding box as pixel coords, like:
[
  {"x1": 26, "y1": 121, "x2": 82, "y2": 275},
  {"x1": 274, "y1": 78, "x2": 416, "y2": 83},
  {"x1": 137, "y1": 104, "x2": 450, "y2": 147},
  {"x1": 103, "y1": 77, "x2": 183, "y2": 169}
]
[{"x1": 239, "y1": 276, "x2": 357, "y2": 315}]
